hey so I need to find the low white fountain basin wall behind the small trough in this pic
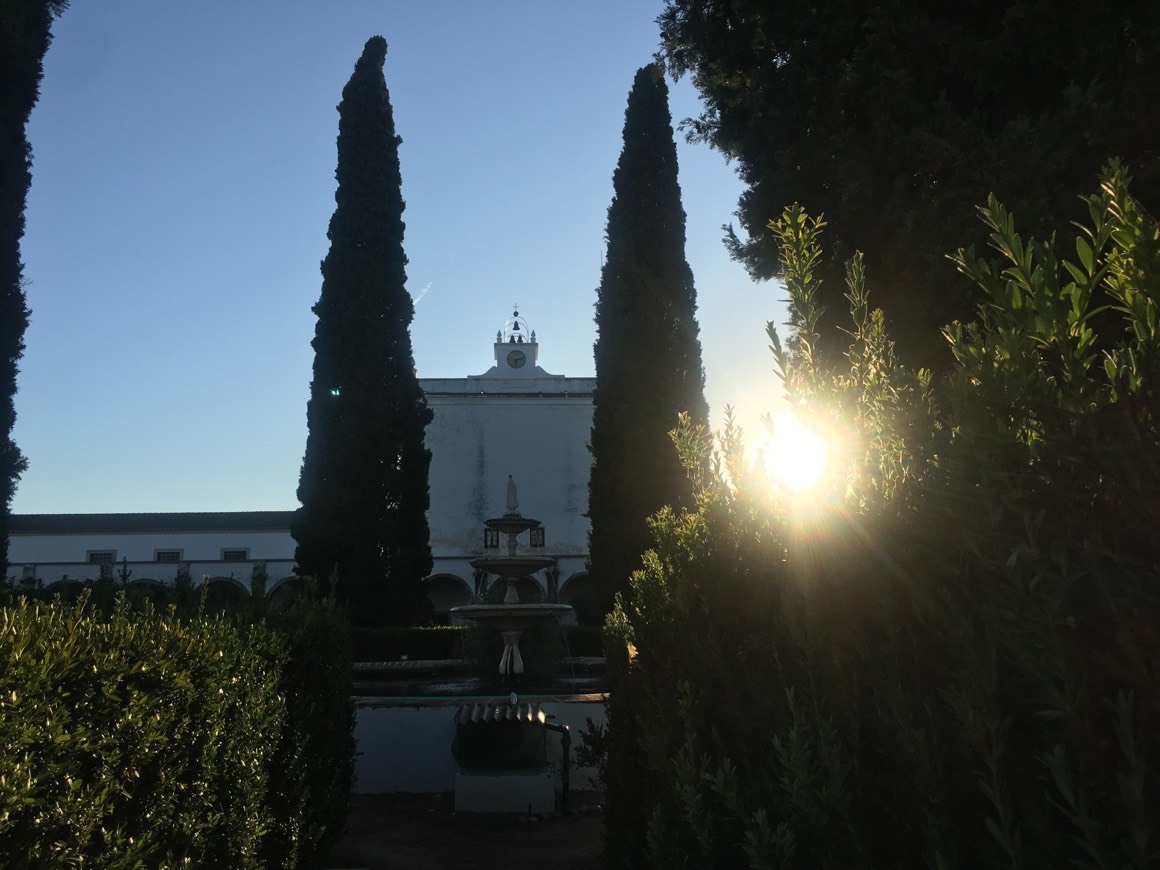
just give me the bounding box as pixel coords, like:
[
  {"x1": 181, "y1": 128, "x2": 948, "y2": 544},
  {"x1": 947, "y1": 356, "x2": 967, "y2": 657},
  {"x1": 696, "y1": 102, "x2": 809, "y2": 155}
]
[{"x1": 355, "y1": 695, "x2": 604, "y2": 795}]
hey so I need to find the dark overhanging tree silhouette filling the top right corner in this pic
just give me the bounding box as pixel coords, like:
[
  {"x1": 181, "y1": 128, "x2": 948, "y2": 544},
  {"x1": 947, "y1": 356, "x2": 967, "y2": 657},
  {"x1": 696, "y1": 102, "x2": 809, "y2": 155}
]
[{"x1": 659, "y1": 0, "x2": 1160, "y2": 369}]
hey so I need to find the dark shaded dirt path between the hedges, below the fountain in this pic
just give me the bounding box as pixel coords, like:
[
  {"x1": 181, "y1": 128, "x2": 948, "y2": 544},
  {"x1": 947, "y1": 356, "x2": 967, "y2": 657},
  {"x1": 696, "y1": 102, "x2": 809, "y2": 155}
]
[{"x1": 326, "y1": 792, "x2": 604, "y2": 870}]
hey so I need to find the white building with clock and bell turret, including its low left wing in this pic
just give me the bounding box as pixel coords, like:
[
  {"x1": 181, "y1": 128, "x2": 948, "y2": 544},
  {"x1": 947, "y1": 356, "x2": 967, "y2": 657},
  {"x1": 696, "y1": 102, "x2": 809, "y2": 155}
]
[{"x1": 8, "y1": 312, "x2": 595, "y2": 614}]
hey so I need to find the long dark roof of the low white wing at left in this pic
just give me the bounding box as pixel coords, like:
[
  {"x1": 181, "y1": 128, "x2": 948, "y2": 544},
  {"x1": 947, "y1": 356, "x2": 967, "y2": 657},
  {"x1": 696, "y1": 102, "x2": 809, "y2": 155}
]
[{"x1": 8, "y1": 510, "x2": 295, "y2": 535}]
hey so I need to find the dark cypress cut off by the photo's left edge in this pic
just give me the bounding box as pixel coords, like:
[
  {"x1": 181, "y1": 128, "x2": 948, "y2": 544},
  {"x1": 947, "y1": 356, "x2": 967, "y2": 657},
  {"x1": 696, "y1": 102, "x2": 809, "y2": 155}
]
[{"x1": 0, "y1": 0, "x2": 68, "y2": 577}]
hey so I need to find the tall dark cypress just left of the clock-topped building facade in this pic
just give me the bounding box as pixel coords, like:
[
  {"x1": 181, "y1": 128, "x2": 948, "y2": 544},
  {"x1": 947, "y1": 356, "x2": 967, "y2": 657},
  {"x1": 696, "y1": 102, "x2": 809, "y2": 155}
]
[{"x1": 292, "y1": 36, "x2": 432, "y2": 624}]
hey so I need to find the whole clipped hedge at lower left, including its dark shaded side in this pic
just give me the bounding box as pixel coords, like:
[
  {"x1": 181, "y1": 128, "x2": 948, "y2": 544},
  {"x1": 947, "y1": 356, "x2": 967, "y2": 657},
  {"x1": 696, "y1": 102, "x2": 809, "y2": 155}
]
[{"x1": 0, "y1": 583, "x2": 355, "y2": 868}]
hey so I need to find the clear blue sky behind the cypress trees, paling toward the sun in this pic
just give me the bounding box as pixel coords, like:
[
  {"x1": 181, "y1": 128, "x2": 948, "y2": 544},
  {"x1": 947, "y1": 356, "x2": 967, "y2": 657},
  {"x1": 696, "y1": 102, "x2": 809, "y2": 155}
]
[{"x1": 13, "y1": 0, "x2": 784, "y2": 513}]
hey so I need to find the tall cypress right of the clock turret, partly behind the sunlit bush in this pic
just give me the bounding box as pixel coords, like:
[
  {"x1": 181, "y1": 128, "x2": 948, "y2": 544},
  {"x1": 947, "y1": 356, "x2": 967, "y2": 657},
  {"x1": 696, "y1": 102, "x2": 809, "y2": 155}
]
[{"x1": 588, "y1": 66, "x2": 709, "y2": 610}]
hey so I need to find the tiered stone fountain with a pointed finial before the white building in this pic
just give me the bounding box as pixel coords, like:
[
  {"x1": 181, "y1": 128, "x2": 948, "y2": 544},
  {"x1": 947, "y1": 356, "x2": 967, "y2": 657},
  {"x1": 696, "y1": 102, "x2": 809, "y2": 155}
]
[{"x1": 451, "y1": 474, "x2": 572, "y2": 679}]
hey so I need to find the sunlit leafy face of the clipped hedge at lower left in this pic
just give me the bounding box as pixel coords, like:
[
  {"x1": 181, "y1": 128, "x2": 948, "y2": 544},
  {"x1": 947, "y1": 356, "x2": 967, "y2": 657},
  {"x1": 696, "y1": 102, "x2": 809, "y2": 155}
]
[{"x1": 0, "y1": 596, "x2": 285, "y2": 868}]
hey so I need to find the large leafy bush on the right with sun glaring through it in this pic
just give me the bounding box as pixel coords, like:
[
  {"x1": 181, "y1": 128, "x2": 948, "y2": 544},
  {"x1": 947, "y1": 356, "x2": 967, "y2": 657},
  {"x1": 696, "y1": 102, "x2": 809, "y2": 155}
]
[{"x1": 606, "y1": 166, "x2": 1160, "y2": 868}]
